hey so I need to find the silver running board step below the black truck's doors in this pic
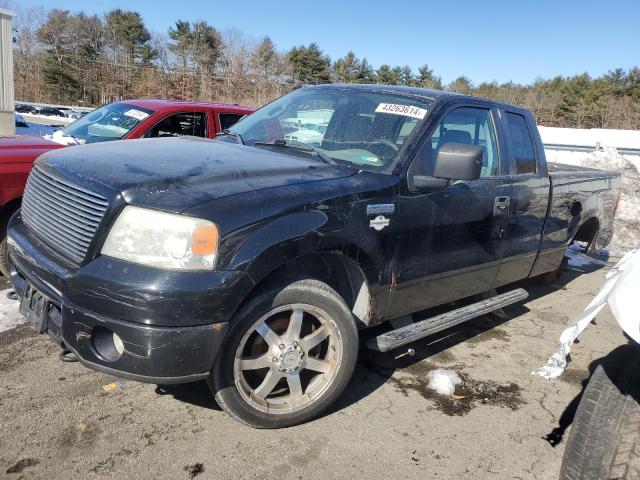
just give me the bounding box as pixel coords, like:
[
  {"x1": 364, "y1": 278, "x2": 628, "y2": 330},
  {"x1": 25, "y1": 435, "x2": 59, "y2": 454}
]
[{"x1": 367, "y1": 288, "x2": 529, "y2": 352}]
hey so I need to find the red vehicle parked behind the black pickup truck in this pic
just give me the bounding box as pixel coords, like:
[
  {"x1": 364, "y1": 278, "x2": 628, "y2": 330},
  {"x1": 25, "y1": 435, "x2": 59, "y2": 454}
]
[{"x1": 0, "y1": 100, "x2": 253, "y2": 275}]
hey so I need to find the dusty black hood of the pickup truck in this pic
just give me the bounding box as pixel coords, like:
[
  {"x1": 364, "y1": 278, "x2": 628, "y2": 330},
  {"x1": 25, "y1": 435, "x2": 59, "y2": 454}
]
[{"x1": 37, "y1": 137, "x2": 356, "y2": 213}]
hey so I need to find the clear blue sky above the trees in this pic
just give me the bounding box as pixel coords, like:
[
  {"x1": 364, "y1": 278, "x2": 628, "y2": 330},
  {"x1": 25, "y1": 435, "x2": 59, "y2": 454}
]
[{"x1": 5, "y1": 0, "x2": 640, "y2": 84}]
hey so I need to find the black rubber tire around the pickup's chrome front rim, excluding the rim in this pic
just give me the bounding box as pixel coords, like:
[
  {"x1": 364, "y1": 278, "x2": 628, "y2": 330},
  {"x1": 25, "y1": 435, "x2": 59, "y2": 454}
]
[{"x1": 209, "y1": 280, "x2": 358, "y2": 428}]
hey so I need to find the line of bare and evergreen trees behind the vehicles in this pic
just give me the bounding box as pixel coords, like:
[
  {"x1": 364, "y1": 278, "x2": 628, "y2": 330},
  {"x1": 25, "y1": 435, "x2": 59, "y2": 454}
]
[{"x1": 14, "y1": 9, "x2": 640, "y2": 129}]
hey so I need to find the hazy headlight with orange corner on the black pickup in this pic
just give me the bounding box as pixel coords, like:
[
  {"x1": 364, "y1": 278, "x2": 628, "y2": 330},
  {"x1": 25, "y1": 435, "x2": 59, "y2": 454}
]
[{"x1": 102, "y1": 205, "x2": 218, "y2": 270}]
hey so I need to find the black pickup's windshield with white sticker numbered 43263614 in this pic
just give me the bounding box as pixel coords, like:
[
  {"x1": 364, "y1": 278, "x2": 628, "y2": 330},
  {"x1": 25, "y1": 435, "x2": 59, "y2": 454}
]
[{"x1": 221, "y1": 87, "x2": 433, "y2": 170}]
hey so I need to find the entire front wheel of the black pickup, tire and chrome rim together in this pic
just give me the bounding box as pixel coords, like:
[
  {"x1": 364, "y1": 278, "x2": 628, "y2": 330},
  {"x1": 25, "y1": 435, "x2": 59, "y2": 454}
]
[{"x1": 209, "y1": 280, "x2": 358, "y2": 428}]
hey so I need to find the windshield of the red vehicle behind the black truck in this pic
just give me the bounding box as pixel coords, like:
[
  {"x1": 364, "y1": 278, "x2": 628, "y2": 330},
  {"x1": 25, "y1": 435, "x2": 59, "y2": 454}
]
[{"x1": 62, "y1": 103, "x2": 154, "y2": 143}]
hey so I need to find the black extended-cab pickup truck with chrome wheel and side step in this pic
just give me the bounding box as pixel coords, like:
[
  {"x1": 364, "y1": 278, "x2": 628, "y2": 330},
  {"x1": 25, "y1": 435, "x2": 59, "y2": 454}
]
[{"x1": 8, "y1": 85, "x2": 621, "y2": 428}]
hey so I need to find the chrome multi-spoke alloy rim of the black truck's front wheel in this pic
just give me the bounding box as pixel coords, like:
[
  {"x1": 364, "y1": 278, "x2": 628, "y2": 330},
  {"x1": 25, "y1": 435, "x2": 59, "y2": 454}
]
[{"x1": 233, "y1": 304, "x2": 343, "y2": 414}]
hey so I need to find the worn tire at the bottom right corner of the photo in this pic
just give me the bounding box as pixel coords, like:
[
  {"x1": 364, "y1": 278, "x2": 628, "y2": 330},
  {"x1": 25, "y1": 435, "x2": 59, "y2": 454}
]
[{"x1": 560, "y1": 365, "x2": 640, "y2": 480}]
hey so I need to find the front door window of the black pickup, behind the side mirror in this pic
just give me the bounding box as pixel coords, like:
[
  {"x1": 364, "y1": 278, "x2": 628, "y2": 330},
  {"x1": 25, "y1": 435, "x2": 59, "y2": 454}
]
[{"x1": 431, "y1": 107, "x2": 500, "y2": 177}]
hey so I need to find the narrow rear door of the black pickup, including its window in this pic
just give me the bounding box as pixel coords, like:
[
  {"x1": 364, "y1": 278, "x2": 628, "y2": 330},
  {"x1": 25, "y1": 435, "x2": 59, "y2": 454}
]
[{"x1": 496, "y1": 108, "x2": 549, "y2": 286}]
